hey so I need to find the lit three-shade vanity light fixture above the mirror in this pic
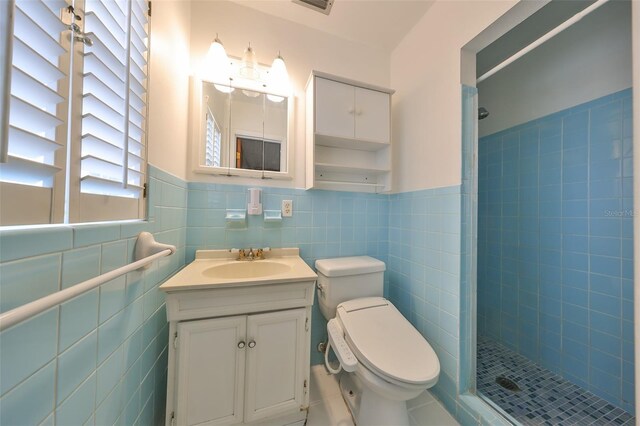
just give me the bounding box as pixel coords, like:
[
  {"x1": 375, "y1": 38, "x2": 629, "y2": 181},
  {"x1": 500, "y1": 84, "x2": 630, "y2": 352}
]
[{"x1": 202, "y1": 34, "x2": 291, "y2": 98}]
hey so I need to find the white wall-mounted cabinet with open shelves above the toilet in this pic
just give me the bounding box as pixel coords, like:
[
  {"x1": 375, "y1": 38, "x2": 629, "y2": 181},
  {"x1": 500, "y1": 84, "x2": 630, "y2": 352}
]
[{"x1": 306, "y1": 71, "x2": 393, "y2": 192}]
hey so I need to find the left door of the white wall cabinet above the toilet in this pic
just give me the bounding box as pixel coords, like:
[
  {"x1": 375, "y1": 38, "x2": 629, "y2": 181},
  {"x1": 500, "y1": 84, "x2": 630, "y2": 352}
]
[{"x1": 315, "y1": 77, "x2": 355, "y2": 139}]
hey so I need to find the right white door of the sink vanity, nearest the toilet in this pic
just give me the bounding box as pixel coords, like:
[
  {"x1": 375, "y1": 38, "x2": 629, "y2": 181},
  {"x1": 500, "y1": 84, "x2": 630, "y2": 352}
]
[{"x1": 244, "y1": 309, "x2": 308, "y2": 422}]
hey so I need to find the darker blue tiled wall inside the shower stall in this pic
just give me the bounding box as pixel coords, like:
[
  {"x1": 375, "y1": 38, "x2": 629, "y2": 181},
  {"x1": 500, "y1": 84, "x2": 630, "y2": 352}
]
[{"x1": 478, "y1": 89, "x2": 634, "y2": 413}]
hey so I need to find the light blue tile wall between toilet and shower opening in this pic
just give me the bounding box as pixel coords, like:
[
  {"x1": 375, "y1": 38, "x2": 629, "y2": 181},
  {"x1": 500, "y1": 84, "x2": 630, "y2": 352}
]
[{"x1": 387, "y1": 186, "x2": 461, "y2": 415}]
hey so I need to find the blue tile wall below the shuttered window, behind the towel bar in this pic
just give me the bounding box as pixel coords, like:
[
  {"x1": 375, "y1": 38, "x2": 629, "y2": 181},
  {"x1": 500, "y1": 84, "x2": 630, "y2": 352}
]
[{"x1": 0, "y1": 166, "x2": 187, "y2": 425}]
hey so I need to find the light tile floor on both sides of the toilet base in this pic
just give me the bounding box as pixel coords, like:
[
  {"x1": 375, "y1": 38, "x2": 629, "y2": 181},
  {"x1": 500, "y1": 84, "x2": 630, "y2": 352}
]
[{"x1": 307, "y1": 365, "x2": 458, "y2": 426}]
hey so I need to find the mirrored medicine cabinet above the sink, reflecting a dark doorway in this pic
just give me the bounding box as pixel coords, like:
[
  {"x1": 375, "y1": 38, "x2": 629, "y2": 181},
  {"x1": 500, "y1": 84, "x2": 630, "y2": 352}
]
[{"x1": 198, "y1": 81, "x2": 290, "y2": 177}]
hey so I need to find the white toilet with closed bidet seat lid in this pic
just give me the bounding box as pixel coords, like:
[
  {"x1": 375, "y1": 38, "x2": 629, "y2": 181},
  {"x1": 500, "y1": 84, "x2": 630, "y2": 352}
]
[{"x1": 316, "y1": 256, "x2": 440, "y2": 426}]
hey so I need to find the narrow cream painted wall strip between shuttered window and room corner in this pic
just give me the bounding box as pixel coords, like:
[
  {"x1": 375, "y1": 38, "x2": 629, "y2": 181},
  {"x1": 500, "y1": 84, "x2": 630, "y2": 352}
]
[{"x1": 147, "y1": 0, "x2": 191, "y2": 179}]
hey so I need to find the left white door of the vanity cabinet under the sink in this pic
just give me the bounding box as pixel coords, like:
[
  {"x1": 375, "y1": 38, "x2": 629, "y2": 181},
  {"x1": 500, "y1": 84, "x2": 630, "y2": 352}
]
[{"x1": 176, "y1": 316, "x2": 247, "y2": 426}]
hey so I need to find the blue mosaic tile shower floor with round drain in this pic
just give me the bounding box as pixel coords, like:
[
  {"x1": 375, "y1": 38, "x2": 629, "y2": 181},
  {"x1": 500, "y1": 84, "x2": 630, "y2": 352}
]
[{"x1": 477, "y1": 337, "x2": 635, "y2": 426}]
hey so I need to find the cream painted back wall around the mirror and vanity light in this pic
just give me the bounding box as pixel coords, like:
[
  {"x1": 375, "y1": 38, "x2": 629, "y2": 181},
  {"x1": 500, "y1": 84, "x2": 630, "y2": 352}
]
[{"x1": 185, "y1": 0, "x2": 390, "y2": 188}]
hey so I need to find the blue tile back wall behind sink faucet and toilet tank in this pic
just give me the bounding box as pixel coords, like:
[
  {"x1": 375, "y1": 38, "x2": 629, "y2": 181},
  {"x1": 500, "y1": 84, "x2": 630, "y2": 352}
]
[{"x1": 186, "y1": 182, "x2": 389, "y2": 364}]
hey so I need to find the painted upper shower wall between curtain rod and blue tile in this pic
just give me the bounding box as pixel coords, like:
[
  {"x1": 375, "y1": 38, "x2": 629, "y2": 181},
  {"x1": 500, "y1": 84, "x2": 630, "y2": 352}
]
[{"x1": 478, "y1": 1, "x2": 632, "y2": 136}]
